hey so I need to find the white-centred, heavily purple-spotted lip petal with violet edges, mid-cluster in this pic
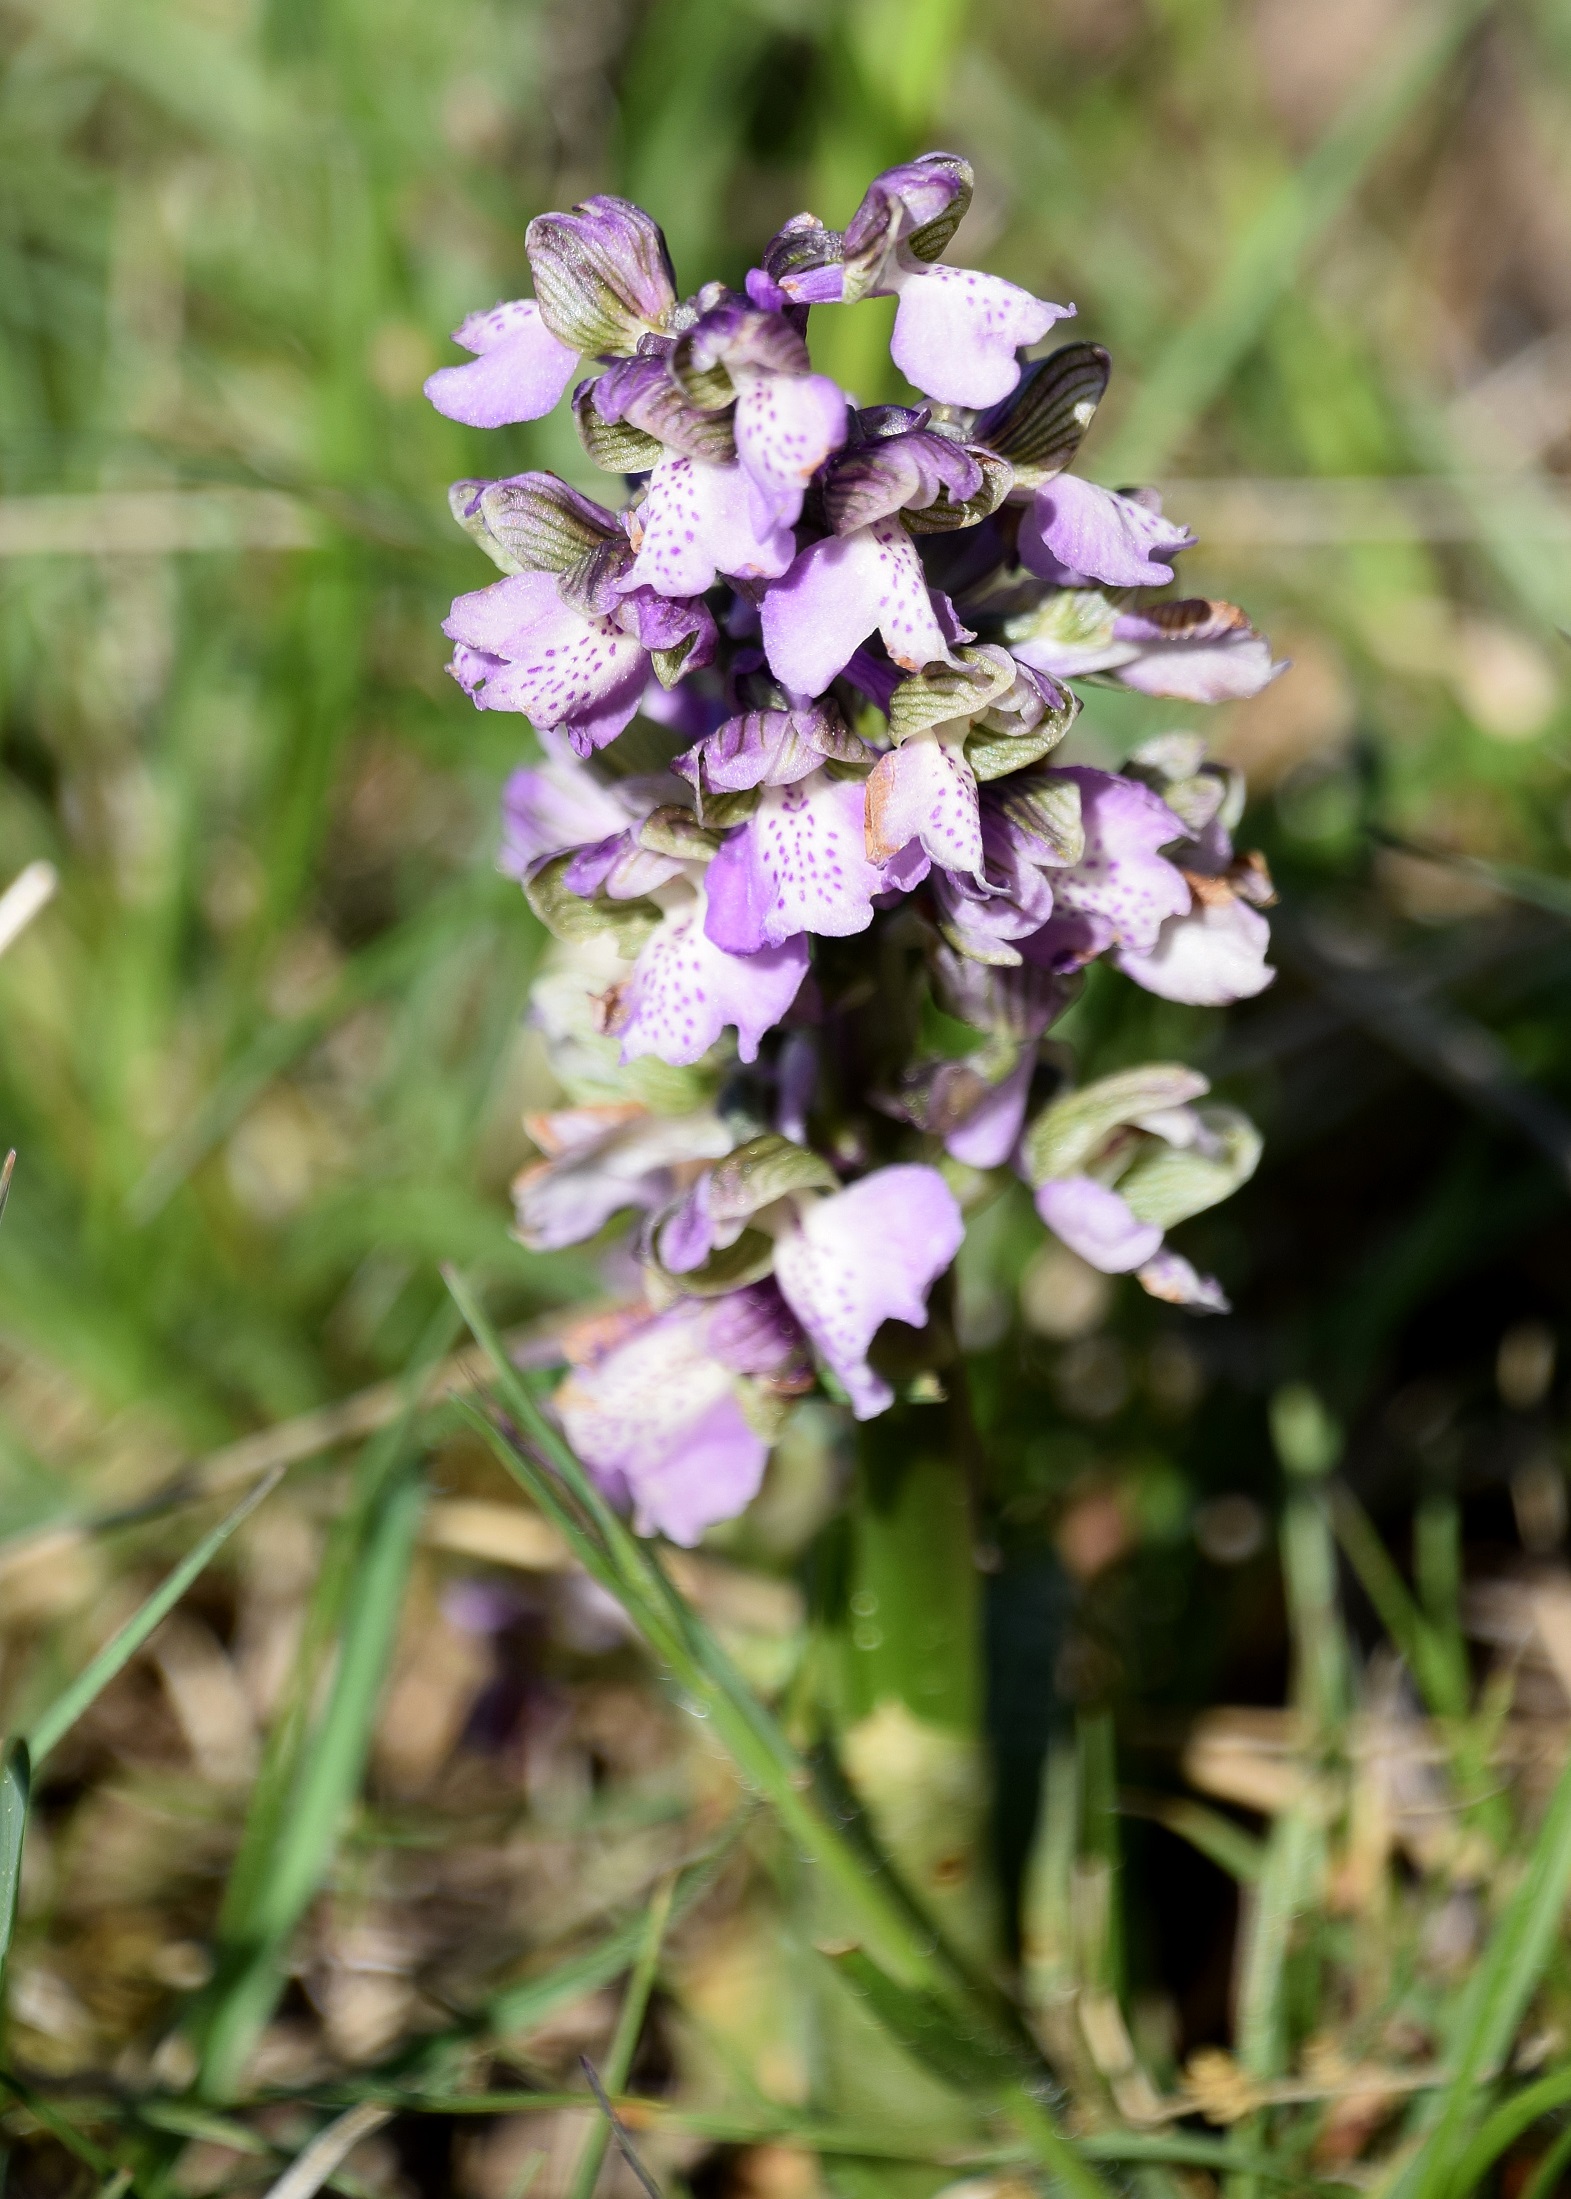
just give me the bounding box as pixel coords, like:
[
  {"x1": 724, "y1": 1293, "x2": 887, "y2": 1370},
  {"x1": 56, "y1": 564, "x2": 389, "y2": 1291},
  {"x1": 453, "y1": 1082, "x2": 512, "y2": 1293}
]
[{"x1": 706, "y1": 774, "x2": 885, "y2": 948}]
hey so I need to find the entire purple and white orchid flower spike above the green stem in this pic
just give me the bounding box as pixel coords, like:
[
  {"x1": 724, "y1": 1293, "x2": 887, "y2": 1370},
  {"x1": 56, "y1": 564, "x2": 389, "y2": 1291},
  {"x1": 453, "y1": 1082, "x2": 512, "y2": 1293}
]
[{"x1": 427, "y1": 154, "x2": 1281, "y2": 1541}]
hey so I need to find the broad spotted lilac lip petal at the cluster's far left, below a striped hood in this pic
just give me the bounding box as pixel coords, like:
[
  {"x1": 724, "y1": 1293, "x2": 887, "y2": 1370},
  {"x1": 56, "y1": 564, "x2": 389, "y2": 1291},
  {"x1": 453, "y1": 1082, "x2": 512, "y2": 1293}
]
[{"x1": 442, "y1": 572, "x2": 649, "y2": 754}]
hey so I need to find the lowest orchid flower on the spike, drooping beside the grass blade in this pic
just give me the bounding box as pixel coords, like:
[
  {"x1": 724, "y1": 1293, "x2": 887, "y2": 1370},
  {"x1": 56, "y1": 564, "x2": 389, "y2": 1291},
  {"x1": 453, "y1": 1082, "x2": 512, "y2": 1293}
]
[{"x1": 554, "y1": 1282, "x2": 801, "y2": 1548}]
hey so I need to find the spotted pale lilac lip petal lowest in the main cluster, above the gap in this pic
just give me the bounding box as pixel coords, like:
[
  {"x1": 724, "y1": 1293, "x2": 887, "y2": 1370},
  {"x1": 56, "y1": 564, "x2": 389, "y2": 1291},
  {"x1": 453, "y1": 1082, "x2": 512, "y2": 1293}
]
[{"x1": 623, "y1": 899, "x2": 808, "y2": 1069}]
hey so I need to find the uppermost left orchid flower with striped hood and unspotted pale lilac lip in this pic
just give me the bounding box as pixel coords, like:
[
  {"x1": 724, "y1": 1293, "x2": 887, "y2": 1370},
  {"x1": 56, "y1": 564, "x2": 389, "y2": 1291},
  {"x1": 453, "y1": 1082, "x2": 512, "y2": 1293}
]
[{"x1": 425, "y1": 198, "x2": 675, "y2": 427}]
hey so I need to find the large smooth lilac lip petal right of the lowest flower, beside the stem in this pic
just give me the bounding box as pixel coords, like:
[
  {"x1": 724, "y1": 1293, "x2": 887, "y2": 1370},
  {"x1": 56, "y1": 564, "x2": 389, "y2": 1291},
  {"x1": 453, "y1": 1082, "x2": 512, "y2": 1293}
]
[{"x1": 774, "y1": 1165, "x2": 966, "y2": 1421}]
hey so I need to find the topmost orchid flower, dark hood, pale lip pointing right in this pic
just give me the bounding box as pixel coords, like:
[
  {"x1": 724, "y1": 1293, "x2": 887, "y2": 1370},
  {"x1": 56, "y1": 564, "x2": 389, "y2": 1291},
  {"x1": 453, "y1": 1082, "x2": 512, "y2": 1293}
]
[{"x1": 748, "y1": 152, "x2": 1074, "y2": 405}]
